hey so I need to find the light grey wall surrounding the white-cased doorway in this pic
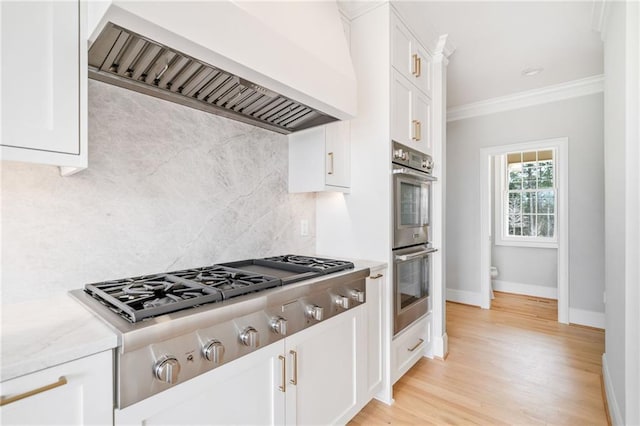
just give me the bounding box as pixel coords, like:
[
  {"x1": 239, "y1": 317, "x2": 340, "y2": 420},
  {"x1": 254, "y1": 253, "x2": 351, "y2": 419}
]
[{"x1": 446, "y1": 94, "x2": 604, "y2": 313}]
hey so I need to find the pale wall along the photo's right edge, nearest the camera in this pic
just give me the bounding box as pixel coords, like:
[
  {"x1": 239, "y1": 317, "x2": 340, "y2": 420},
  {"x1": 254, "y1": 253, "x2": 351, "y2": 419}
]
[{"x1": 603, "y1": 2, "x2": 640, "y2": 425}]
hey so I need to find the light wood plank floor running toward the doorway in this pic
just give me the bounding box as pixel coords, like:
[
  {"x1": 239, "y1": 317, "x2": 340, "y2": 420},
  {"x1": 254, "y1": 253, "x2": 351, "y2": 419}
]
[{"x1": 351, "y1": 294, "x2": 607, "y2": 425}]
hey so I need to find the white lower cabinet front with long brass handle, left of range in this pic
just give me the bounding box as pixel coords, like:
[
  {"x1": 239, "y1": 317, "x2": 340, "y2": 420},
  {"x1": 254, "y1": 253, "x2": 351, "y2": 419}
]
[{"x1": 0, "y1": 351, "x2": 113, "y2": 425}]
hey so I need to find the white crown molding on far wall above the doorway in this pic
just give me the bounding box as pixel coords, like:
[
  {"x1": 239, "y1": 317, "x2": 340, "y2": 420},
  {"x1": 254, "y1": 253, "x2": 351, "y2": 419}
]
[{"x1": 447, "y1": 74, "x2": 604, "y2": 122}]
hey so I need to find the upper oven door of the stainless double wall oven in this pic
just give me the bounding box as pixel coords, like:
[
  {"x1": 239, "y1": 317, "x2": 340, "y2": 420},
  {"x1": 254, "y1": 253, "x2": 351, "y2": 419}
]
[{"x1": 393, "y1": 165, "x2": 435, "y2": 249}]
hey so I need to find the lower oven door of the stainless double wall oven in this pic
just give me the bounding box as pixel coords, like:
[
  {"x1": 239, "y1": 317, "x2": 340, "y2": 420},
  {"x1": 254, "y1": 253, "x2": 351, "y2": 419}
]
[{"x1": 393, "y1": 245, "x2": 437, "y2": 335}]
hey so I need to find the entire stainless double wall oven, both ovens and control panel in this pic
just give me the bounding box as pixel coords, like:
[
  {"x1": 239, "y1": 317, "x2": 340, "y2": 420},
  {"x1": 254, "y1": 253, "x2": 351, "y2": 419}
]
[{"x1": 391, "y1": 142, "x2": 437, "y2": 334}]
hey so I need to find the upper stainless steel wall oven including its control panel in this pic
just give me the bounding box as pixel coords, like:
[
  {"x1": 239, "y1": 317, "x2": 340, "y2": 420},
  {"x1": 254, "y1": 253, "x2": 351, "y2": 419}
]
[{"x1": 392, "y1": 142, "x2": 436, "y2": 249}]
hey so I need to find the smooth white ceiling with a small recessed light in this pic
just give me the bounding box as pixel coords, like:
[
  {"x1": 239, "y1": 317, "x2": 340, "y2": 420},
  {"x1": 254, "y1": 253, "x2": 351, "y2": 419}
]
[{"x1": 360, "y1": 0, "x2": 603, "y2": 107}]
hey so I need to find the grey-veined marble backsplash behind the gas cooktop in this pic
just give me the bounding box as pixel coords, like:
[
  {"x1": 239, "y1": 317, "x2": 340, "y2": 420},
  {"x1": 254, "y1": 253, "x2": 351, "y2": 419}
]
[{"x1": 0, "y1": 80, "x2": 315, "y2": 303}]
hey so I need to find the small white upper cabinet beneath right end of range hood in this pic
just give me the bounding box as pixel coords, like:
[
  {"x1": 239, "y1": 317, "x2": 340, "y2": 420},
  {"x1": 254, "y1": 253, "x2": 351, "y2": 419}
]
[{"x1": 289, "y1": 121, "x2": 351, "y2": 192}]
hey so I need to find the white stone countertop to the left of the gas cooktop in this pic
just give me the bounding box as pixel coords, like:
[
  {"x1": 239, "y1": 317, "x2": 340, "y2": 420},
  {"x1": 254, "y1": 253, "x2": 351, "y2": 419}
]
[{"x1": 0, "y1": 294, "x2": 118, "y2": 381}]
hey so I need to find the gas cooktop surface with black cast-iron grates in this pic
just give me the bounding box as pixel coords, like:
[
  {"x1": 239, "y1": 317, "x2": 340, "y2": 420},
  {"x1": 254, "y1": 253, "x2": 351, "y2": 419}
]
[{"x1": 85, "y1": 254, "x2": 354, "y2": 323}]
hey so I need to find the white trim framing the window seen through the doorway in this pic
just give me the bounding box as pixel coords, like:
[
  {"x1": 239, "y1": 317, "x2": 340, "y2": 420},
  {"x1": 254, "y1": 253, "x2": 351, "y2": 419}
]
[{"x1": 493, "y1": 139, "x2": 568, "y2": 248}]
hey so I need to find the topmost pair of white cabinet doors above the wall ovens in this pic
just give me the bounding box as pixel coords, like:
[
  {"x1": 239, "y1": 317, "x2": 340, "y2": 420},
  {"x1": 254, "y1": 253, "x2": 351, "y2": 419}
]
[{"x1": 391, "y1": 14, "x2": 431, "y2": 97}]
